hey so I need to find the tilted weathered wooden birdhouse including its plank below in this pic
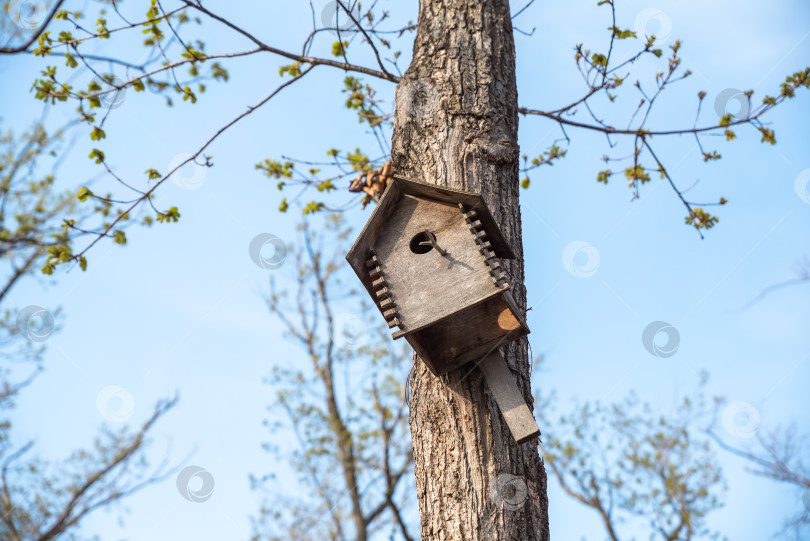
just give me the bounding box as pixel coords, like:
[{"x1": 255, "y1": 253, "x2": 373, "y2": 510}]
[{"x1": 346, "y1": 176, "x2": 539, "y2": 442}]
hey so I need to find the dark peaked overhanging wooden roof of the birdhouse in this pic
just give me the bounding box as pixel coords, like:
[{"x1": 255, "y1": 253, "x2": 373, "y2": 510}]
[{"x1": 346, "y1": 175, "x2": 515, "y2": 277}]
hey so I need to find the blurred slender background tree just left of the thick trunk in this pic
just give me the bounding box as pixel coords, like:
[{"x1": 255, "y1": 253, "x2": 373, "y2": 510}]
[{"x1": 253, "y1": 215, "x2": 414, "y2": 541}]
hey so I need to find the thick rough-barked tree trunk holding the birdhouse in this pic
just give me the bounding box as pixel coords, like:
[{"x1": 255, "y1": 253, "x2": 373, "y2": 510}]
[{"x1": 391, "y1": 0, "x2": 549, "y2": 541}]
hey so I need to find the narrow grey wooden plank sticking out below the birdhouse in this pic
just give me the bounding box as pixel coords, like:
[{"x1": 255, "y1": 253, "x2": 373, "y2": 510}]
[{"x1": 478, "y1": 349, "x2": 540, "y2": 443}]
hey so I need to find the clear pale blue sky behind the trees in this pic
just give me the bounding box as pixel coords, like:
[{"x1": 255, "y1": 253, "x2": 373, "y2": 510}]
[{"x1": 0, "y1": 0, "x2": 810, "y2": 541}]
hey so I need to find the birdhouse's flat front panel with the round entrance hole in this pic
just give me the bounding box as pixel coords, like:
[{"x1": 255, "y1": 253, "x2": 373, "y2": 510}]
[{"x1": 374, "y1": 195, "x2": 498, "y2": 332}]
